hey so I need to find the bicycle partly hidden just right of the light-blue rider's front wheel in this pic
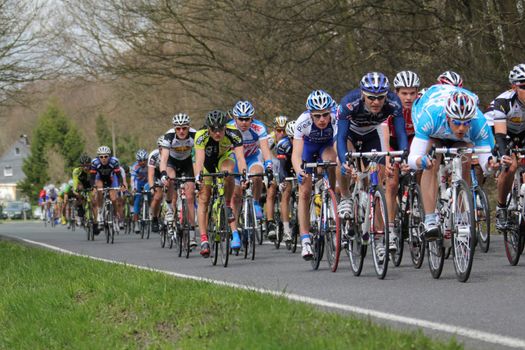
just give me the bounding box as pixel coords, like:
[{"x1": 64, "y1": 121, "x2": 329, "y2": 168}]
[{"x1": 470, "y1": 155, "x2": 490, "y2": 253}]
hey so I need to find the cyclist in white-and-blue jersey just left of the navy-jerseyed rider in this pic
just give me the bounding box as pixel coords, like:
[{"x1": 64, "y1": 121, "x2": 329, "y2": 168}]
[{"x1": 292, "y1": 90, "x2": 337, "y2": 260}]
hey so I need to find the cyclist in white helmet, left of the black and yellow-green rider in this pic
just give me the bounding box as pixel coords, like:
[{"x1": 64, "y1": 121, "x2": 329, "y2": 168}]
[{"x1": 159, "y1": 113, "x2": 196, "y2": 241}]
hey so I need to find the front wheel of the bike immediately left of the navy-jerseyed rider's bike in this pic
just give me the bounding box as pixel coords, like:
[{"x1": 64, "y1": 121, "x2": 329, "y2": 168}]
[{"x1": 321, "y1": 189, "x2": 341, "y2": 272}]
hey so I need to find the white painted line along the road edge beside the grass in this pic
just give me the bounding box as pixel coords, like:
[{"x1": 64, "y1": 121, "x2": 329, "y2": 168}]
[{"x1": 21, "y1": 238, "x2": 525, "y2": 349}]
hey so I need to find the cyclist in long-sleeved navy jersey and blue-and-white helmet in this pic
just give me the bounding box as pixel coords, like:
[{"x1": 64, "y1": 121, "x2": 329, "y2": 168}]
[{"x1": 337, "y1": 72, "x2": 408, "y2": 256}]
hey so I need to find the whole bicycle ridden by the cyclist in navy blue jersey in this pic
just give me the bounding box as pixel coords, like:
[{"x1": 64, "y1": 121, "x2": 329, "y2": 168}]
[{"x1": 343, "y1": 150, "x2": 404, "y2": 279}]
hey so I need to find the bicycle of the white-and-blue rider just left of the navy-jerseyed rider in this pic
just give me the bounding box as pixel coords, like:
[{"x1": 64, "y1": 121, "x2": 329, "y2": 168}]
[{"x1": 303, "y1": 161, "x2": 341, "y2": 272}]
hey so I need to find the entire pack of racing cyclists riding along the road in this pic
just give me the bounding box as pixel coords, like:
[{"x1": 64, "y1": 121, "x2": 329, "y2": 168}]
[{"x1": 40, "y1": 64, "x2": 525, "y2": 276}]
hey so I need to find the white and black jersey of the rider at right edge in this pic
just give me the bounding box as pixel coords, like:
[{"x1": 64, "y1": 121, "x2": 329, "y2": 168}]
[{"x1": 485, "y1": 90, "x2": 525, "y2": 135}]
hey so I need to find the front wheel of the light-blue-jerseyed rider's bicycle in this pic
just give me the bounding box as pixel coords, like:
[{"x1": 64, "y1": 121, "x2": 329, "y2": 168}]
[{"x1": 452, "y1": 180, "x2": 476, "y2": 282}]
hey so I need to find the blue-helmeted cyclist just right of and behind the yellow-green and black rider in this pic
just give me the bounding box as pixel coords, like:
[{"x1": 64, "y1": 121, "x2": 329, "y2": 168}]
[{"x1": 228, "y1": 100, "x2": 275, "y2": 243}]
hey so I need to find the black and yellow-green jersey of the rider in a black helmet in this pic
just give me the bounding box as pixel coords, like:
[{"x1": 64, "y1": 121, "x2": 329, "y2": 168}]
[{"x1": 195, "y1": 125, "x2": 243, "y2": 172}]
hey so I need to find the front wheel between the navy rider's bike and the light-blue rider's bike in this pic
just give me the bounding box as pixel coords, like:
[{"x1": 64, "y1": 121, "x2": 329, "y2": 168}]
[{"x1": 408, "y1": 184, "x2": 425, "y2": 269}]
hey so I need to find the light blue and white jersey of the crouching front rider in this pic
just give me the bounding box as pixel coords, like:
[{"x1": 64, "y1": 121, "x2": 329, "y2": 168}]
[{"x1": 412, "y1": 85, "x2": 494, "y2": 148}]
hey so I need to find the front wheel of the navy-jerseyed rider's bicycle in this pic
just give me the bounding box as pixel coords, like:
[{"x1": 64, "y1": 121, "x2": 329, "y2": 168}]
[{"x1": 370, "y1": 186, "x2": 390, "y2": 279}]
